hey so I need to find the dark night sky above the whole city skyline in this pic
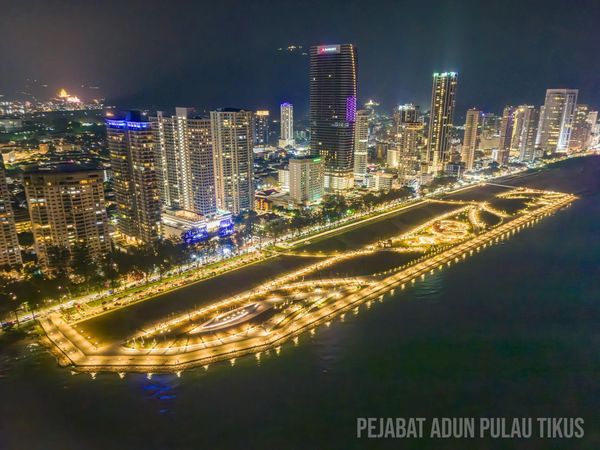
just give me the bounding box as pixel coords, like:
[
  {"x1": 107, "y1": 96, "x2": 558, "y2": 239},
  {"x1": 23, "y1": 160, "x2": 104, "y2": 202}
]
[{"x1": 0, "y1": 0, "x2": 600, "y2": 118}]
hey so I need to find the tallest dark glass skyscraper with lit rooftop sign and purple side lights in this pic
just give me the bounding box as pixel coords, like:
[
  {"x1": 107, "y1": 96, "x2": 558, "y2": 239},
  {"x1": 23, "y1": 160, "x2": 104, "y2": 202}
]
[{"x1": 310, "y1": 44, "x2": 357, "y2": 191}]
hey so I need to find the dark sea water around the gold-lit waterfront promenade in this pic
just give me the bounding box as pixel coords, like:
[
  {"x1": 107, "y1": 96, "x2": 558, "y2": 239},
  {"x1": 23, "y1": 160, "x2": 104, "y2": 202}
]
[{"x1": 0, "y1": 157, "x2": 600, "y2": 450}]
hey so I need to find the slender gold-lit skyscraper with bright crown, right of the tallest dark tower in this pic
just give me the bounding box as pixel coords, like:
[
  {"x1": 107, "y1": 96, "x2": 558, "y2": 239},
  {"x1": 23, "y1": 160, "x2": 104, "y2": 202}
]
[{"x1": 426, "y1": 72, "x2": 458, "y2": 174}]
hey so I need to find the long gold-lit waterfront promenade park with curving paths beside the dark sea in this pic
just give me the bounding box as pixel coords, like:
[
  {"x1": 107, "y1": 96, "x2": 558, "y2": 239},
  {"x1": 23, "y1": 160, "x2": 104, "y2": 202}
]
[{"x1": 40, "y1": 184, "x2": 576, "y2": 376}]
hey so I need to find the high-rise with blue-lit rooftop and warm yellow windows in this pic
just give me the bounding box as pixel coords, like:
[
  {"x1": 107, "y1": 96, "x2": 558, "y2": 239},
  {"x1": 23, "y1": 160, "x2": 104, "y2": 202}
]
[{"x1": 106, "y1": 111, "x2": 161, "y2": 244}]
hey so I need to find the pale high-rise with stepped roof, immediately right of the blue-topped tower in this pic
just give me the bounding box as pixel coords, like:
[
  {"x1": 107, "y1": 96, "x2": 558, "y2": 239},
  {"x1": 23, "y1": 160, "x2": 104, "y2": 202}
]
[{"x1": 150, "y1": 108, "x2": 217, "y2": 216}]
